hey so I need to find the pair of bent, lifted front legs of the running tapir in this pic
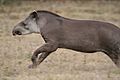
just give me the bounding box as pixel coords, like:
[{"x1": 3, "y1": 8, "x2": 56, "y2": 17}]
[{"x1": 29, "y1": 42, "x2": 58, "y2": 68}]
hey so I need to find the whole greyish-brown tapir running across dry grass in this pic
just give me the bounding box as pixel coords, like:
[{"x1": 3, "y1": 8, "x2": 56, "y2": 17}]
[{"x1": 12, "y1": 10, "x2": 120, "y2": 68}]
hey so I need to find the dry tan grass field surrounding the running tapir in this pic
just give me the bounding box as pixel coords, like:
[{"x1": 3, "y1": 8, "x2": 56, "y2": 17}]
[{"x1": 0, "y1": 0, "x2": 120, "y2": 80}]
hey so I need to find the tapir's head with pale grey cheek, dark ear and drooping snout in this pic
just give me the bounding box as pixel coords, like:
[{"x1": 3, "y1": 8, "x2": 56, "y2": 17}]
[{"x1": 12, "y1": 11, "x2": 40, "y2": 36}]
